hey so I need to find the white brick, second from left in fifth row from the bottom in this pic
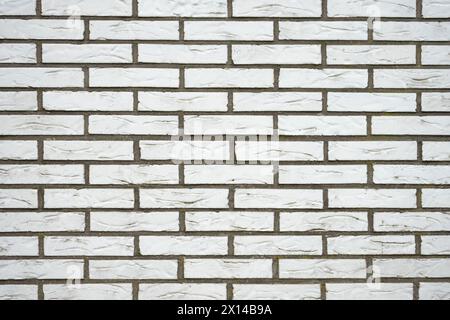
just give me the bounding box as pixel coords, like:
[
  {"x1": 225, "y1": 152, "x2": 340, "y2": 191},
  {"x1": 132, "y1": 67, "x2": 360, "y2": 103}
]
[{"x1": 44, "y1": 189, "x2": 134, "y2": 208}]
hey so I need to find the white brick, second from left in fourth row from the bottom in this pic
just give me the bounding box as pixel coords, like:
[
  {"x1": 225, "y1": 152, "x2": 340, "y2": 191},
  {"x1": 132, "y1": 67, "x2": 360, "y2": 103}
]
[{"x1": 90, "y1": 212, "x2": 179, "y2": 232}]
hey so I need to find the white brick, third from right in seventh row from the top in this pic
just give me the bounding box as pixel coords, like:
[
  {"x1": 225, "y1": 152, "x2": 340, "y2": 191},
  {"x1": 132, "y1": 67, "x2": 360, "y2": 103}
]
[{"x1": 236, "y1": 140, "x2": 323, "y2": 161}]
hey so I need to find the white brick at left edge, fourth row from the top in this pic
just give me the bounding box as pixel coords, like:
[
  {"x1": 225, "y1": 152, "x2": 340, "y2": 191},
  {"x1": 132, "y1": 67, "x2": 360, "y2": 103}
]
[{"x1": 0, "y1": 67, "x2": 84, "y2": 88}]
